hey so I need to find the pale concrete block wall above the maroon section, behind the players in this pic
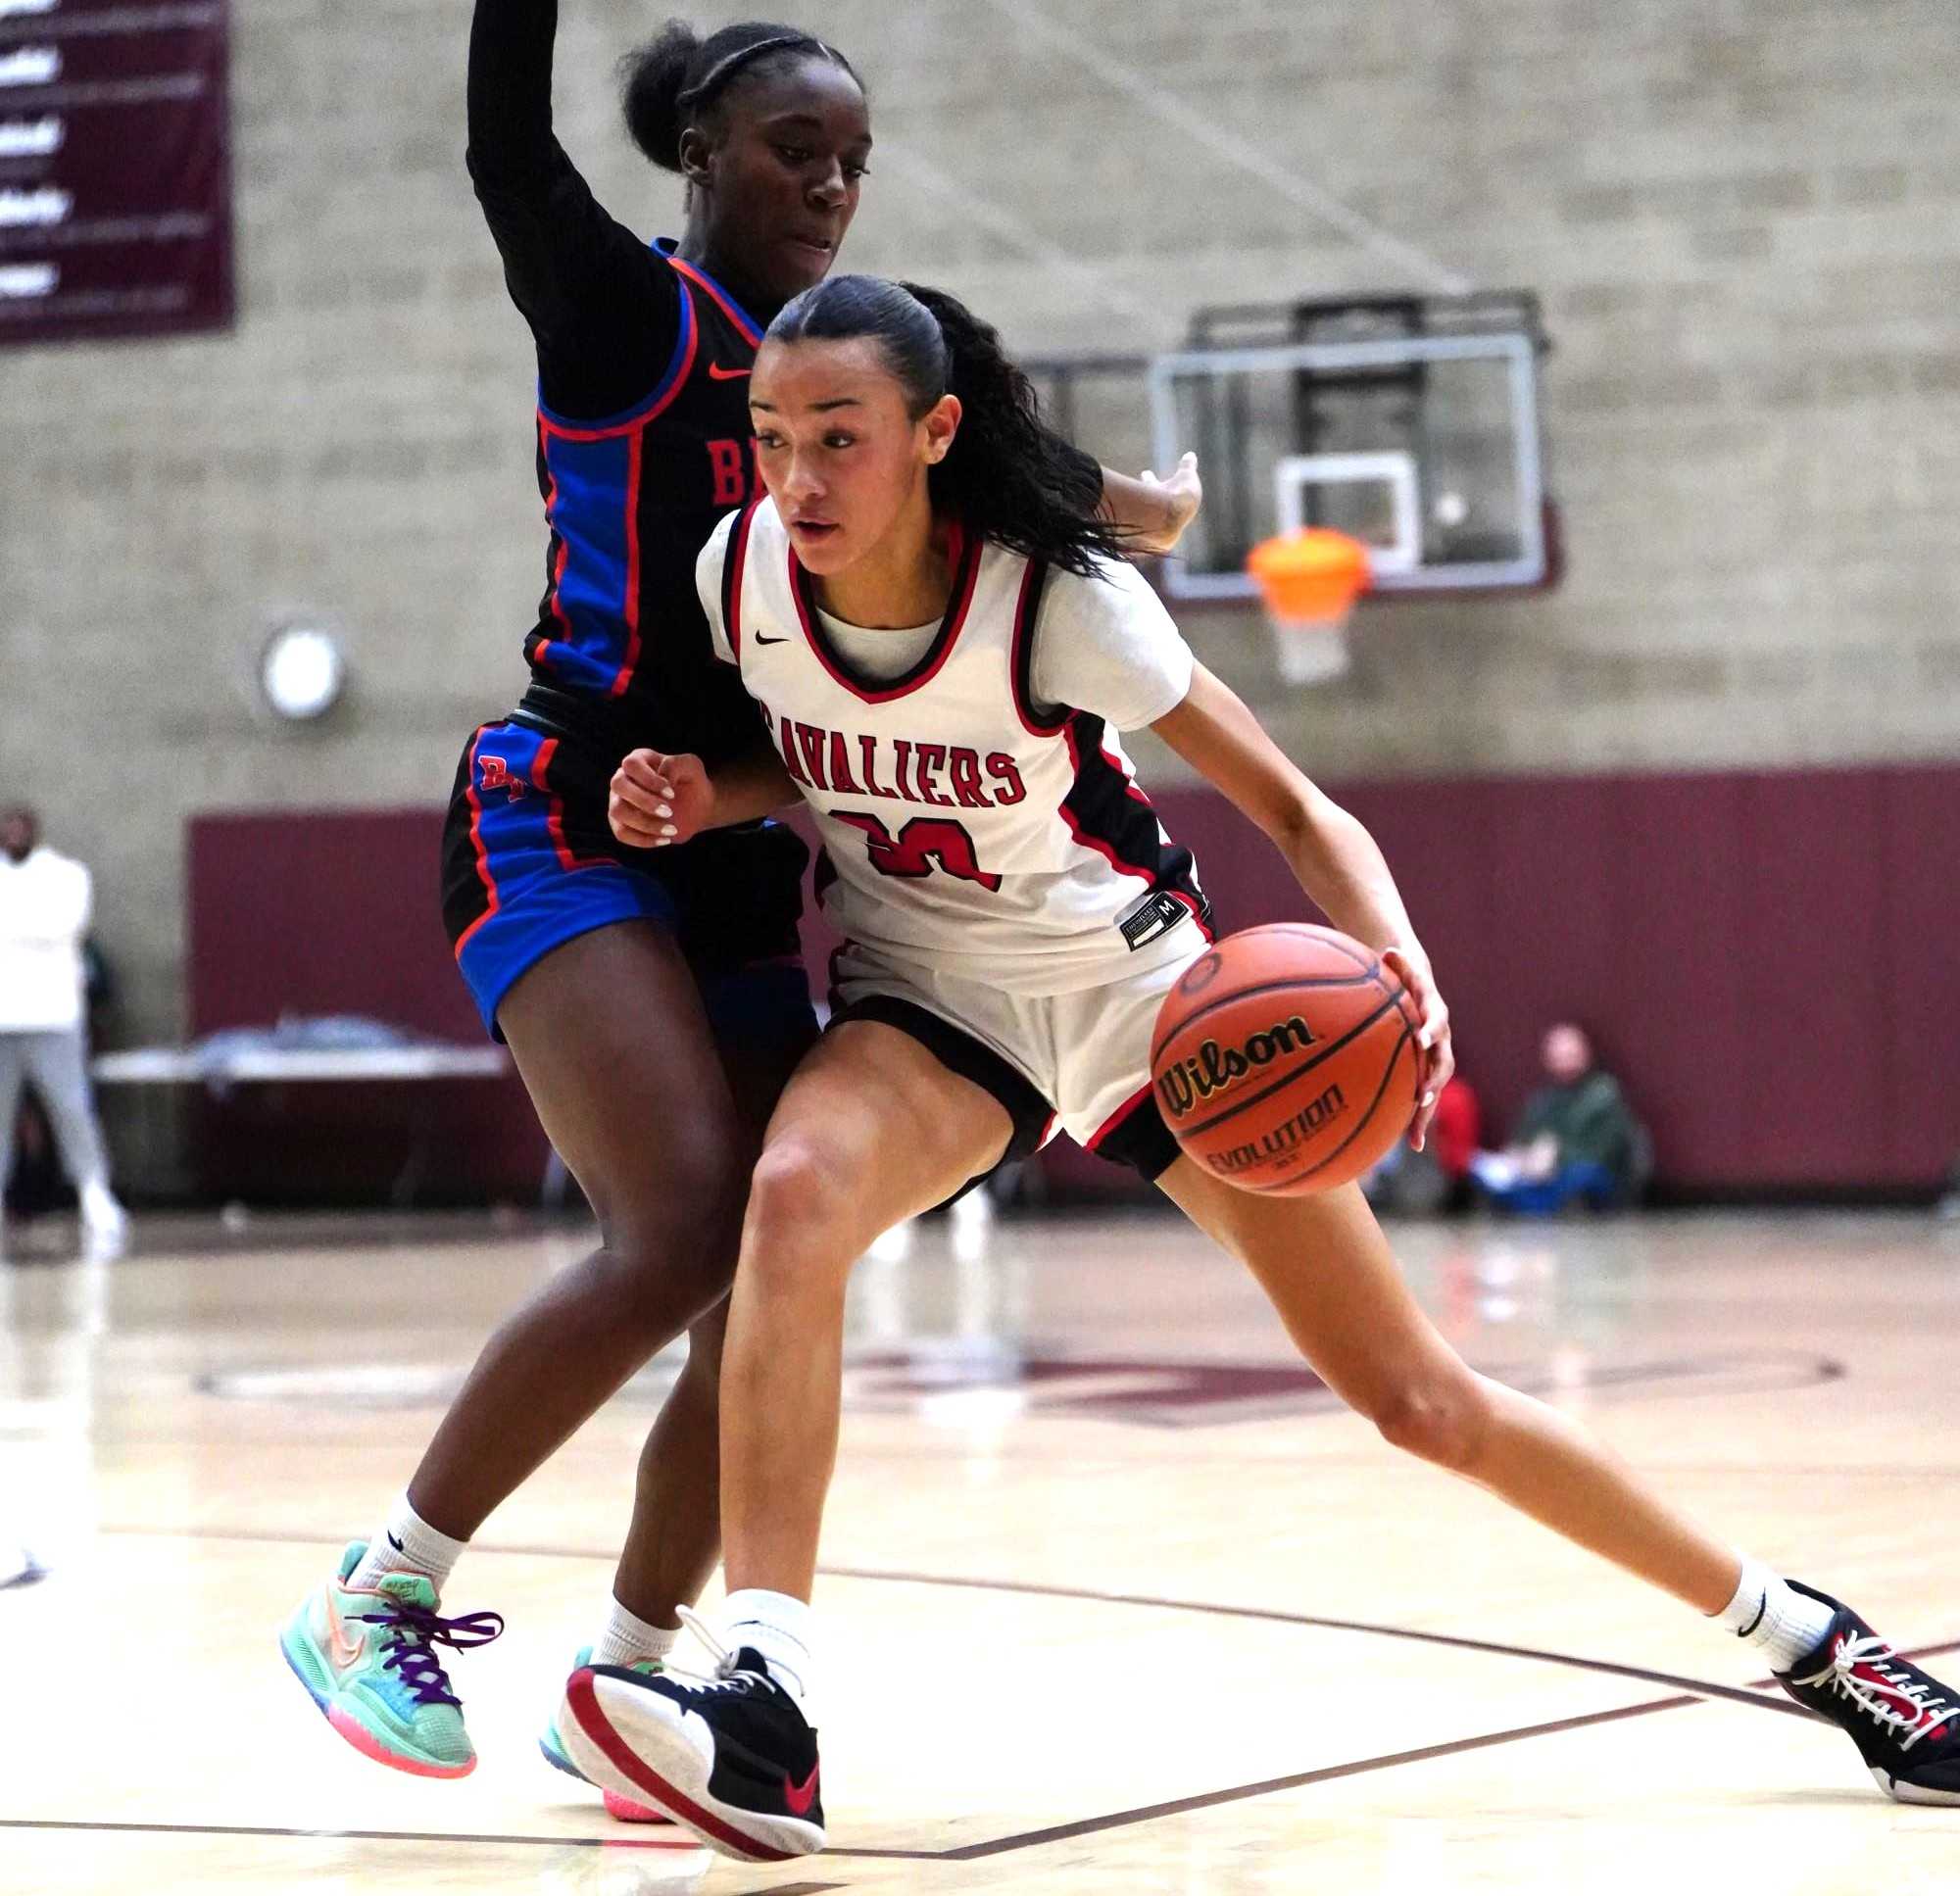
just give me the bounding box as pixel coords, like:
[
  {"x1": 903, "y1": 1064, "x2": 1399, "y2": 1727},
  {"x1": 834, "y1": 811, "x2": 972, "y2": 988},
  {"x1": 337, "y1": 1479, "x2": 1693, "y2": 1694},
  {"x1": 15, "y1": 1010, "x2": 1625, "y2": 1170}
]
[{"x1": 0, "y1": 0, "x2": 1960, "y2": 1036}]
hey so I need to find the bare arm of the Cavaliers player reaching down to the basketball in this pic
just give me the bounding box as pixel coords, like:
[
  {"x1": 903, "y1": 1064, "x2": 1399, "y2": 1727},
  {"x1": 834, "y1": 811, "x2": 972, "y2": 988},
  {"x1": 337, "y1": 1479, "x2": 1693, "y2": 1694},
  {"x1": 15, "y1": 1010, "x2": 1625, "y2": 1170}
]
[{"x1": 1151, "y1": 666, "x2": 1456, "y2": 1149}]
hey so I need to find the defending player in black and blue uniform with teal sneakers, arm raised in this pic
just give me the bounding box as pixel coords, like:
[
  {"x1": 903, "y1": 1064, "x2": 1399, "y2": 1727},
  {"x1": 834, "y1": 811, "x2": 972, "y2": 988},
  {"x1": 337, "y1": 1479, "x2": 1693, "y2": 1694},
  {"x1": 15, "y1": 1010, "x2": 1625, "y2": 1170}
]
[{"x1": 284, "y1": 0, "x2": 1198, "y2": 1810}]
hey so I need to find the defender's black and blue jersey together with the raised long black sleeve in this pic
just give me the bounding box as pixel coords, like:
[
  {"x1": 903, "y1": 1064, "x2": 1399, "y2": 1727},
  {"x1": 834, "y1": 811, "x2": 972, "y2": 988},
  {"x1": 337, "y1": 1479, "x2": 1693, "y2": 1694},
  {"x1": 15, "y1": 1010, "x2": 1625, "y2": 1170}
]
[{"x1": 468, "y1": 0, "x2": 774, "y2": 762}]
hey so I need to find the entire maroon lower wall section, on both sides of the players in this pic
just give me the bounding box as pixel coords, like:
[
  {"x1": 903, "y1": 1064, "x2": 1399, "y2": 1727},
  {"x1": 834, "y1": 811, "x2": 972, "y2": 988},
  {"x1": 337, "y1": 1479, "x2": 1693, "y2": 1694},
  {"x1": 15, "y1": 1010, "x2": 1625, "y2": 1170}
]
[{"x1": 190, "y1": 766, "x2": 1960, "y2": 1191}]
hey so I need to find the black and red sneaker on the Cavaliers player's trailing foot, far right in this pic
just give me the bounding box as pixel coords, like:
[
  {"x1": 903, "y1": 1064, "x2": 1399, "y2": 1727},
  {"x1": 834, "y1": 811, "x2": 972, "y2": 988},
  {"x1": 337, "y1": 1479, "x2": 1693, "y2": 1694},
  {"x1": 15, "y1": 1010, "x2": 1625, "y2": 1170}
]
[{"x1": 1776, "y1": 1580, "x2": 1960, "y2": 1804}]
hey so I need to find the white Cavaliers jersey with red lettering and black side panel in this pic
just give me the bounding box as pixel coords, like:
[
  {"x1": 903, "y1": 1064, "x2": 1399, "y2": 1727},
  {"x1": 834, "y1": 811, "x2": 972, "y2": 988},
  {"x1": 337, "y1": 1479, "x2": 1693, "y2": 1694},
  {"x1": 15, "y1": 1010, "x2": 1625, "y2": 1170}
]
[{"x1": 702, "y1": 498, "x2": 1209, "y2": 993}]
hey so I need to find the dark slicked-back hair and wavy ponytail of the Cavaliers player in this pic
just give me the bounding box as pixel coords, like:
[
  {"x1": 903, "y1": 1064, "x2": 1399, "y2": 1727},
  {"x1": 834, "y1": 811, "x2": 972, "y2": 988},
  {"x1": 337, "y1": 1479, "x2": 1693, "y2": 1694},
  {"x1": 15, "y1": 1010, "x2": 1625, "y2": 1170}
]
[{"x1": 768, "y1": 276, "x2": 1123, "y2": 578}]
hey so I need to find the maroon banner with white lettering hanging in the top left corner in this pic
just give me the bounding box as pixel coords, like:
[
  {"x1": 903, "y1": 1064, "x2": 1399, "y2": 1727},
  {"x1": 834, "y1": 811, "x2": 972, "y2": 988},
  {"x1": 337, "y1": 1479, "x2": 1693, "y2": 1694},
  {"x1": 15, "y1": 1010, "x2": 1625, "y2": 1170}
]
[{"x1": 0, "y1": 0, "x2": 233, "y2": 345}]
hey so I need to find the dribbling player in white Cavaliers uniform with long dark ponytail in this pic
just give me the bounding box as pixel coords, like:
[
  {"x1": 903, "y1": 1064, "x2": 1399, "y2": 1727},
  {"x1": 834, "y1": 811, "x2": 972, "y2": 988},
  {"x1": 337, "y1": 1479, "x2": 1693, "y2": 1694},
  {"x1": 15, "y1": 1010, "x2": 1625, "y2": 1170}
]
[{"x1": 559, "y1": 276, "x2": 1960, "y2": 1859}]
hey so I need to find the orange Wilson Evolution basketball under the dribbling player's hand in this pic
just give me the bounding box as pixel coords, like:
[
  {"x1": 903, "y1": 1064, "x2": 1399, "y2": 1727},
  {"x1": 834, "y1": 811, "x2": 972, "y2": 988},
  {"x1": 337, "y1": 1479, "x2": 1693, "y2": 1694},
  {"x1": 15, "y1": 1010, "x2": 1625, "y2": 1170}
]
[{"x1": 1151, "y1": 923, "x2": 1421, "y2": 1196}]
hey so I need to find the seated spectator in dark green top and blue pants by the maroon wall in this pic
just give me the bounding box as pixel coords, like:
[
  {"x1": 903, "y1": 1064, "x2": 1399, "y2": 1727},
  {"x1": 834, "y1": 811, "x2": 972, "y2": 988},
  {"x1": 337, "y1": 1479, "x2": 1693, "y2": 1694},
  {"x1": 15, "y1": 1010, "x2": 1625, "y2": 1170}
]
[{"x1": 1470, "y1": 1020, "x2": 1646, "y2": 1212}]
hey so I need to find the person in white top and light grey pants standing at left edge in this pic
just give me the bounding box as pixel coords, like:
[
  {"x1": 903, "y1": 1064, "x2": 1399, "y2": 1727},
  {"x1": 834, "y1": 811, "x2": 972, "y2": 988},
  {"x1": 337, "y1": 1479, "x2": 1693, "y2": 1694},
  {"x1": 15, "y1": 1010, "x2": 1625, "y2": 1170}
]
[{"x1": 0, "y1": 807, "x2": 129, "y2": 1257}]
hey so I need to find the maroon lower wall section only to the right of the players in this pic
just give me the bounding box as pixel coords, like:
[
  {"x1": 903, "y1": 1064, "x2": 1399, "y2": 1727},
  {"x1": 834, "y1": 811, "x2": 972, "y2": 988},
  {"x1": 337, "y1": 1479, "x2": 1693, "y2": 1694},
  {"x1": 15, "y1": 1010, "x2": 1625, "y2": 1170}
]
[{"x1": 1158, "y1": 768, "x2": 1960, "y2": 1189}]
